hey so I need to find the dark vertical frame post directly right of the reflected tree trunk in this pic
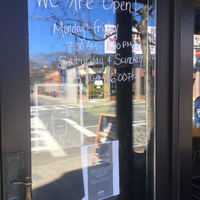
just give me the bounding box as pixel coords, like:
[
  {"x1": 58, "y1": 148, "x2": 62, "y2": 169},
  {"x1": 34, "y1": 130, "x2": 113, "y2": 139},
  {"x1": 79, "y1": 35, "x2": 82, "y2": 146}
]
[{"x1": 155, "y1": 0, "x2": 171, "y2": 200}]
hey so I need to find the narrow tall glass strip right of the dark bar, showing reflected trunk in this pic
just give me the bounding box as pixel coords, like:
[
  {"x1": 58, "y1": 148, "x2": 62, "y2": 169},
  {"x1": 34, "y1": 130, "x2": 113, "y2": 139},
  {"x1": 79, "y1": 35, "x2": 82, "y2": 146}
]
[{"x1": 133, "y1": 1, "x2": 156, "y2": 199}]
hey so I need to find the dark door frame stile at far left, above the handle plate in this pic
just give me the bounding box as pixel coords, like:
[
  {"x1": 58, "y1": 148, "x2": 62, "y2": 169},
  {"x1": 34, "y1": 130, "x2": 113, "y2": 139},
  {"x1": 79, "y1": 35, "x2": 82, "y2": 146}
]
[{"x1": 0, "y1": 0, "x2": 31, "y2": 199}]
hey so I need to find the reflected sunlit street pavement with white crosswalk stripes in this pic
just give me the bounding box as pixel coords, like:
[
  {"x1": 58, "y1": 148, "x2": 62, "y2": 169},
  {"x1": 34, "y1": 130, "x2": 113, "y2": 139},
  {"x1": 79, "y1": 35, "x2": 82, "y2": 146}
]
[{"x1": 31, "y1": 95, "x2": 146, "y2": 195}]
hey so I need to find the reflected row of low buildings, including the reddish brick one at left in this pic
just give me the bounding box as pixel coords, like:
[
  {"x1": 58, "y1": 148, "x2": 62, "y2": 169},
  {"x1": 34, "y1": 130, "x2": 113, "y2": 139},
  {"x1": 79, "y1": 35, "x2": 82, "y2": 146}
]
[{"x1": 42, "y1": 54, "x2": 154, "y2": 101}]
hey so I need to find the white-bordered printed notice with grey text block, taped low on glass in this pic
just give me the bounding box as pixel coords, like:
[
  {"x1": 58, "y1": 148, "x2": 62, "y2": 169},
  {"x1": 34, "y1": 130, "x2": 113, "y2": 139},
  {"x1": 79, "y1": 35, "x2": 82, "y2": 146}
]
[{"x1": 81, "y1": 140, "x2": 119, "y2": 200}]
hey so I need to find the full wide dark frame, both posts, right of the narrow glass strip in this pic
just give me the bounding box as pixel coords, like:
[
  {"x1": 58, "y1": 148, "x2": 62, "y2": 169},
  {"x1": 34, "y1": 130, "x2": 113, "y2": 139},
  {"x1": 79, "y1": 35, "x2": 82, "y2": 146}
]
[{"x1": 156, "y1": 0, "x2": 194, "y2": 200}]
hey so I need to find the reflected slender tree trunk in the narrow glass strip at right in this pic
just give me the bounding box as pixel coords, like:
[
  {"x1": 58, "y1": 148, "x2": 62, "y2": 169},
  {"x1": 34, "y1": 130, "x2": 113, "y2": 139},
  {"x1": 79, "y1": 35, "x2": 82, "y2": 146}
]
[{"x1": 133, "y1": 4, "x2": 154, "y2": 141}]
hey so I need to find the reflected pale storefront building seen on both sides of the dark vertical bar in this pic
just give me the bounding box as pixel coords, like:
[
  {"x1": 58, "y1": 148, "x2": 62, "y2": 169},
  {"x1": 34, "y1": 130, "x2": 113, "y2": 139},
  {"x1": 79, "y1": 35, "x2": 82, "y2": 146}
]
[{"x1": 57, "y1": 54, "x2": 154, "y2": 100}]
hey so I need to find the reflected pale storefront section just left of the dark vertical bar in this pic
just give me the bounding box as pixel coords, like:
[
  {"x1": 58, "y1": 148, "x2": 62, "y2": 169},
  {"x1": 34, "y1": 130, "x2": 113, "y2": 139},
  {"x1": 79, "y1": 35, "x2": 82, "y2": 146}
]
[{"x1": 60, "y1": 54, "x2": 114, "y2": 99}]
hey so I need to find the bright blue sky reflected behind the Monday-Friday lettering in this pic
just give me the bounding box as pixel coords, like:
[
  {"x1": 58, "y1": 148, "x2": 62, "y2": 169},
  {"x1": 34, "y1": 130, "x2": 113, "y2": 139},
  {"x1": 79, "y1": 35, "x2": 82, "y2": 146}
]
[{"x1": 28, "y1": 0, "x2": 114, "y2": 57}]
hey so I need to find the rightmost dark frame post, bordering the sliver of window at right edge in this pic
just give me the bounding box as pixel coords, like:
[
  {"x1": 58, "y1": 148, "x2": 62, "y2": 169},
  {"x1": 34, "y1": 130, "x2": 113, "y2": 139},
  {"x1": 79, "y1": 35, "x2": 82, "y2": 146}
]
[{"x1": 172, "y1": 0, "x2": 194, "y2": 200}]
